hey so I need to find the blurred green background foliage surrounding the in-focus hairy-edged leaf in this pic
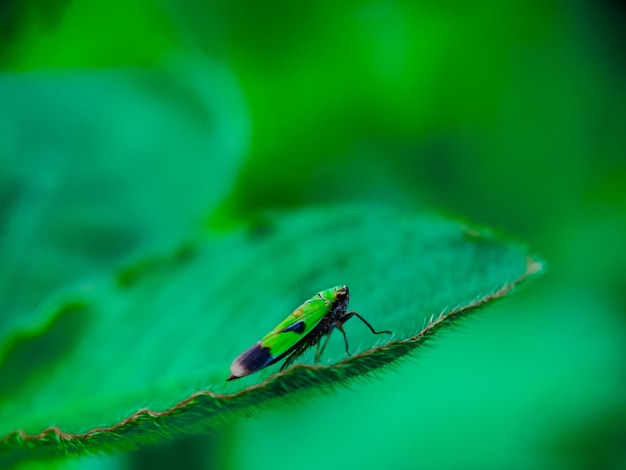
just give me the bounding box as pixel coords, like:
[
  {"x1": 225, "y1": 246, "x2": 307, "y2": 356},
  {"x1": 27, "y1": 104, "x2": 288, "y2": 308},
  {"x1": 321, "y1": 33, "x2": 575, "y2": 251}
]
[{"x1": 0, "y1": 0, "x2": 626, "y2": 469}]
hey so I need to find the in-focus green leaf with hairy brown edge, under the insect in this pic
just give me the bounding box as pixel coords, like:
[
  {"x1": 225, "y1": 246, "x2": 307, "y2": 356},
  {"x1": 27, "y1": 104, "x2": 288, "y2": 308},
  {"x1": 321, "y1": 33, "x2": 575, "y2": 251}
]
[{"x1": 0, "y1": 206, "x2": 541, "y2": 464}]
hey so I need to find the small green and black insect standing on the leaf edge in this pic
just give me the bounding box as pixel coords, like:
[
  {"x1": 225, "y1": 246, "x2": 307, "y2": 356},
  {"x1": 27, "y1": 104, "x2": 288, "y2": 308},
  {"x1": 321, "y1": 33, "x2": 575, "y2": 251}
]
[{"x1": 227, "y1": 286, "x2": 391, "y2": 380}]
